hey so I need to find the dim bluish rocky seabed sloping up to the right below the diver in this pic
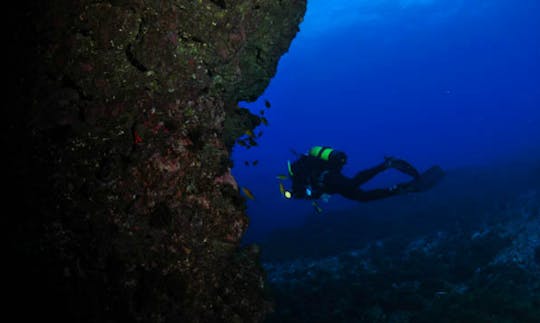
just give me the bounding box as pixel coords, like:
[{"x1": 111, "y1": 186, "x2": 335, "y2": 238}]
[{"x1": 265, "y1": 190, "x2": 540, "y2": 323}]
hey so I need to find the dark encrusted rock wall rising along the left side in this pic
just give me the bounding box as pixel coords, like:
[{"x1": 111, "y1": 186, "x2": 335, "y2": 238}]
[{"x1": 3, "y1": 0, "x2": 306, "y2": 322}]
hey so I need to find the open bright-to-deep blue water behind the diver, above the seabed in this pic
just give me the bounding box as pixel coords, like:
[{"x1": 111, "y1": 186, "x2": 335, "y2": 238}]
[{"x1": 233, "y1": 0, "x2": 540, "y2": 242}]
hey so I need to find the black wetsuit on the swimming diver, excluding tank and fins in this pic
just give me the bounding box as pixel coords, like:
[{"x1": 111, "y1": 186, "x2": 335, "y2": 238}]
[{"x1": 292, "y1": 156, "x2": 420, "y2": 202}]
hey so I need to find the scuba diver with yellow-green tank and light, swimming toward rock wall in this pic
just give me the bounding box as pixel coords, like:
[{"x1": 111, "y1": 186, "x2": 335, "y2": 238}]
[{"x1": 278, "y1": 146, "x2": 444, "y2": 212}]
